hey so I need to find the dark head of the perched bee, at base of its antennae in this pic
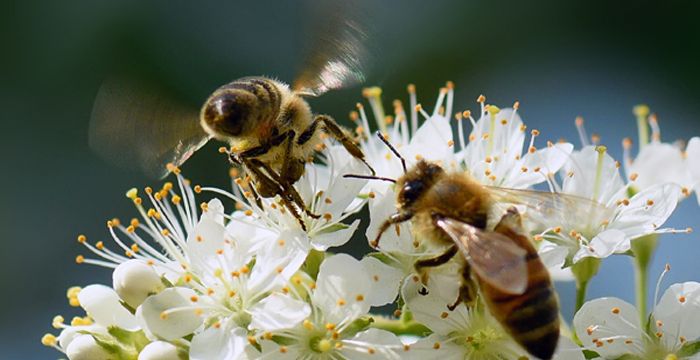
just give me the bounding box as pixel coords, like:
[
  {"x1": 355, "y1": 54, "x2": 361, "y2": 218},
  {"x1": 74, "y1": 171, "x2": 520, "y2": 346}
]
[{"x1": 396, "y1": 160, "x2": 445, "y2": 207}]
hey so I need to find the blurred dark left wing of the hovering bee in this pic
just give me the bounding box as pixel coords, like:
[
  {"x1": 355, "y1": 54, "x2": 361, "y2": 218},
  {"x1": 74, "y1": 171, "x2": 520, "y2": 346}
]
[{"x1": 89, "y1": 79, "x2": 210, "y2": 178}]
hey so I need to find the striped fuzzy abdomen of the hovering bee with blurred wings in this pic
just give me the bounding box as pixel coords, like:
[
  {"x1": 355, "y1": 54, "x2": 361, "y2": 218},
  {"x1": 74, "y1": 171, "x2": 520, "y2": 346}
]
[{"x1": 201, "y1": 77, "x2": 282, "y2": 139}]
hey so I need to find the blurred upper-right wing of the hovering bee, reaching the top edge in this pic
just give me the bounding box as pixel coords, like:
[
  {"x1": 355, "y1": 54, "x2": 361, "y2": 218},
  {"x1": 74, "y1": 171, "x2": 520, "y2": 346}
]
[{"x1": 292, "y1": 0, "x2": 368, "y2": 96}]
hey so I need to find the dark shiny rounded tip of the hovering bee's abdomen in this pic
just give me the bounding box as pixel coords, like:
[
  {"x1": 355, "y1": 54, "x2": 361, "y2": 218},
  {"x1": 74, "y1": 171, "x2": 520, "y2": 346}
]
[{"x1": 201, "y1": 91, "x2": 257, "y2": 139}]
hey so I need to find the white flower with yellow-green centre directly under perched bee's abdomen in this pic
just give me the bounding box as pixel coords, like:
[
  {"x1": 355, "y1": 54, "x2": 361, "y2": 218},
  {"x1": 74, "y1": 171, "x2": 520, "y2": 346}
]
[{"x1": 402, "y1": 273, "x2": 584, "y2": 360}]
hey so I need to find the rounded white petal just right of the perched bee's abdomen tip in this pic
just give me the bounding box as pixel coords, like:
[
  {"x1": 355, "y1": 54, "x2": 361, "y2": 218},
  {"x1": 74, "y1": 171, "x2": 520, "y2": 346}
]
[{"x1": 574, "y1": 298, "x2": 644, "y2": 359}]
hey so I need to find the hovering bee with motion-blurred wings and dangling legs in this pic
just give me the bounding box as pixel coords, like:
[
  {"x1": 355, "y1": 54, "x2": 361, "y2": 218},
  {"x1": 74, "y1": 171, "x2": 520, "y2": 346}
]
[{"x1": 90, "y1": 2, "x2": 374, "y2": 229}]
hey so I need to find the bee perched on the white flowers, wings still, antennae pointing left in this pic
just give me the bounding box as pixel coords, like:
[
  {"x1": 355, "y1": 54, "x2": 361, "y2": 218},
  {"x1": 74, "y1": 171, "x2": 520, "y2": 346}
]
[{"x1": 345, "y1": 135, "x2": 611, "y2": 359}]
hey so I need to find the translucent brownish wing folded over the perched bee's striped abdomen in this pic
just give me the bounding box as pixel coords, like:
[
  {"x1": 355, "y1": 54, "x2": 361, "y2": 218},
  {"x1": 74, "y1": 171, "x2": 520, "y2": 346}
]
[{"x1": 437, "y1": 218, "x2": 527, "y2": 295}]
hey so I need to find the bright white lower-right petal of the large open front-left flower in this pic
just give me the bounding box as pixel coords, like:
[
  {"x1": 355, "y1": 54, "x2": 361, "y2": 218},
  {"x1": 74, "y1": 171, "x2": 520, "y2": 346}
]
[{"x1": 249, "y1": 293, "x2": 311, "y2": 331}]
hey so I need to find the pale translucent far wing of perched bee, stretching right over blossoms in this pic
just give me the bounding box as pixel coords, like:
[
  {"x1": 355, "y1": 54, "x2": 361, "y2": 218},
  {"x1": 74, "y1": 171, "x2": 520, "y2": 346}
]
[{"x1": 486, "y1": 186, "x2": 615, "y2": 231}]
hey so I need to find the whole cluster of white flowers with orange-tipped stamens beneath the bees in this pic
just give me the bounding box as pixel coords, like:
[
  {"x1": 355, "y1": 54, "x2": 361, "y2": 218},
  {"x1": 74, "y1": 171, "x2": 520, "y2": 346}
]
[{"x1": 42, "y1": 83, "x2": 700, "y2": 360}]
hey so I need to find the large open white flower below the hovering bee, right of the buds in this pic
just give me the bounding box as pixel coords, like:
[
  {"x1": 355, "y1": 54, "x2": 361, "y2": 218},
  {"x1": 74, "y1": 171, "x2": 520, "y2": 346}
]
[{"x1": 137, "y1": 200, "x2": 306, "y2": 359}]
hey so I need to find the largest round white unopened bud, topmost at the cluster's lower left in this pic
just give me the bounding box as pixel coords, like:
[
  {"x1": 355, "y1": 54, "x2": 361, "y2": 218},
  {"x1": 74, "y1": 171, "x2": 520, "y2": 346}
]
[{"x1": 112, "y1": 260, "x2": 164, "y2": 309}]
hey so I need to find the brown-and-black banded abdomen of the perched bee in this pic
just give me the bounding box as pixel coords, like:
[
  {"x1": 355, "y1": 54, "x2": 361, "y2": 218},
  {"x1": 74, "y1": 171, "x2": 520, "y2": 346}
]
[{"x1": 480, "y1": 224, "x2": 559, "y2": 360}]
